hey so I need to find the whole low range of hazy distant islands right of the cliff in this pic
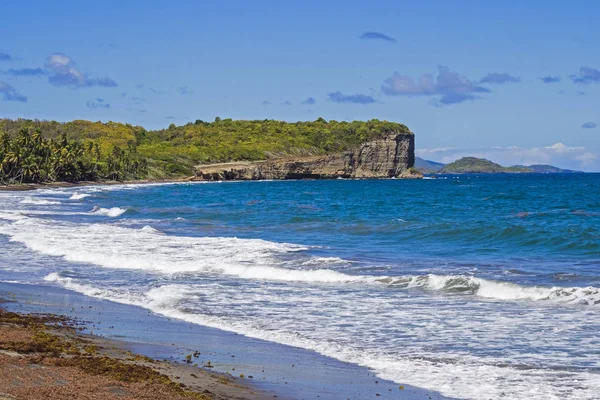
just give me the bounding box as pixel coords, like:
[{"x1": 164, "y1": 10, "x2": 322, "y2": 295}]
[{"x1": 415, "y1": 157, "x2": 581, "y2": 174}]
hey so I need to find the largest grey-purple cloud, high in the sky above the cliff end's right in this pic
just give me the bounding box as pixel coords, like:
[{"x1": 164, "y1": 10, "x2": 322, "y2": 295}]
[{"x1": 381, "y1": 66, "x2": 491, "y2": 106}]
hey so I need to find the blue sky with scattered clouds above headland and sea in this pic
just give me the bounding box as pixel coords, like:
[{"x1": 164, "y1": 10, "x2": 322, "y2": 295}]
[{"x1": 0, "y1": 0, "x2": 600, "y2": 171}]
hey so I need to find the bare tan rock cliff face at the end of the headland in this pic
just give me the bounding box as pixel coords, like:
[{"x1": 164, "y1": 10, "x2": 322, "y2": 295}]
[{"x1": 196, "y1": 133, "x2": 416, "y2": 181}]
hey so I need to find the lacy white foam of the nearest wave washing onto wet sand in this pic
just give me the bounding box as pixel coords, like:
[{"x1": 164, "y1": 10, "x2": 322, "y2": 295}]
[{"x1": 41, "y1": 274, "x2": 600, "y2": 399}]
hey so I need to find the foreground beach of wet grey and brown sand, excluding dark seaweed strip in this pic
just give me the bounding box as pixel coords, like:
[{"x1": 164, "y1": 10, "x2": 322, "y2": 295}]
[{"x1": 0, "y1": 283, "x2": 445, "y2": 400}]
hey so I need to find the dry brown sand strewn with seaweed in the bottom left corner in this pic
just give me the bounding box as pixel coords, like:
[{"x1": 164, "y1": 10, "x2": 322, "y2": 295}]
[{"x1": 0, "y1": 297, "x2": 278, "y2": 400}]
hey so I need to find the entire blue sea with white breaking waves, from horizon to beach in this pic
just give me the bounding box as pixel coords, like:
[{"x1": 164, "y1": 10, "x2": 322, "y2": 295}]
[{"x1": 0, "y1": 174, "x2": 600, "y2": 399}]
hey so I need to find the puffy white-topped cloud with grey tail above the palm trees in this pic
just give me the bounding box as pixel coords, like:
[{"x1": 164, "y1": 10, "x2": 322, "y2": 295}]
[{"x1": 46, "y1": 53, "x2": 118, "y2": 89}]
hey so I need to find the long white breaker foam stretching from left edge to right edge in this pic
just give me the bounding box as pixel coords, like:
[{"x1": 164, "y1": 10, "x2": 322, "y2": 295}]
[{"x1": 0, "y1": 214, "x2": 600, "y2": 306}]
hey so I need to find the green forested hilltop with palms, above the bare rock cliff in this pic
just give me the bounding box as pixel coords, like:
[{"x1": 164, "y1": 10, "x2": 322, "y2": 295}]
[{"x1": 0, "y1": 118, "x2": 412, "y2": 183}]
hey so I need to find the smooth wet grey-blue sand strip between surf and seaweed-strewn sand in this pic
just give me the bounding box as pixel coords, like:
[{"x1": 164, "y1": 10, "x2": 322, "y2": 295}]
[{"x1": 0, "y1": 282, "x2": 446, "y2": 400}]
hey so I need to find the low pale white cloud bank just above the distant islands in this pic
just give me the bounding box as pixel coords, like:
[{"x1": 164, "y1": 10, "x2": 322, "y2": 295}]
[{"x1": 415, "y1": 143, "x2": 600, "y2": 172}]
